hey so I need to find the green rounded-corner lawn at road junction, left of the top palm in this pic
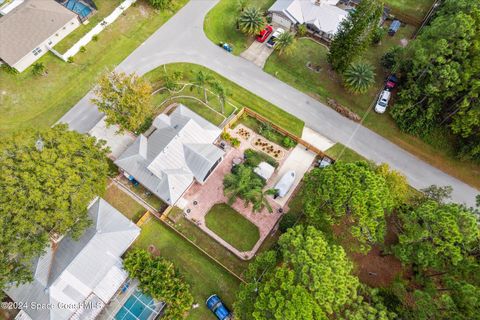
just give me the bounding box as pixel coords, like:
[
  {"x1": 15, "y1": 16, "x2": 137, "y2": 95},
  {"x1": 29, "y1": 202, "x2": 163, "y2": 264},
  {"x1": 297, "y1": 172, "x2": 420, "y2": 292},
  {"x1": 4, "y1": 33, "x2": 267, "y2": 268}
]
[{"x1": 203, "y1": 0, "x2": 275, "y2": 55}]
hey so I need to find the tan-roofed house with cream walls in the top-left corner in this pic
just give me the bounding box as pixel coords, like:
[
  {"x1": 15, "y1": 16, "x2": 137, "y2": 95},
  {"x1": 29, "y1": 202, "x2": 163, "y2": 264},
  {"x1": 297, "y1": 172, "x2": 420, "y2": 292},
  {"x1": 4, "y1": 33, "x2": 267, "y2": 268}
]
[{"x1": 0, "y1": 0, "x2": 80, "y2": 72}]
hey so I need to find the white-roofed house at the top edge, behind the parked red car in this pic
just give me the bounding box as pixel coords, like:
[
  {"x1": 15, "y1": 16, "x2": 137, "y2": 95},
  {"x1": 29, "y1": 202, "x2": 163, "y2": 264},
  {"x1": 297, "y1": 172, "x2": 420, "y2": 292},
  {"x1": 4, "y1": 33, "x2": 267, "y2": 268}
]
[{"x1": 268, "y1": 0, "x2": 348, "y2": 42}]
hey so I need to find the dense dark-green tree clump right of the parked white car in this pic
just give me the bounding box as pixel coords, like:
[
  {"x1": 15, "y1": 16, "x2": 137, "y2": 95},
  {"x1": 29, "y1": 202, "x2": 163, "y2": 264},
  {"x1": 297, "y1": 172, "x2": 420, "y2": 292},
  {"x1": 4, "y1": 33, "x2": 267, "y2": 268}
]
[{"x1": 391, "y1": 0, "x2": 480, "y2": 161}]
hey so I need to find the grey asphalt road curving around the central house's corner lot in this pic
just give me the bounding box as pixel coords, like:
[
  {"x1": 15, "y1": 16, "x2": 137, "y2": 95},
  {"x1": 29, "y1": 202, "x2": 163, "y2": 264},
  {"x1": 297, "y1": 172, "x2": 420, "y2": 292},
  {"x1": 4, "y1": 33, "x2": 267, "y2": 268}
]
[{"x1": 60, "y1": 0, "x2": 479, "y2": 206}]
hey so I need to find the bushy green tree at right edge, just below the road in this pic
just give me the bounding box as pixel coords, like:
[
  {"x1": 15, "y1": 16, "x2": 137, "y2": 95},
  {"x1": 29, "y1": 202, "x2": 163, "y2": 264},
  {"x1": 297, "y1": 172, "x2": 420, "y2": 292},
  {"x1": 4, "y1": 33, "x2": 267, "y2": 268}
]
[{"x1": 394, "y1": 200, "x2": 480, "y2": 271}]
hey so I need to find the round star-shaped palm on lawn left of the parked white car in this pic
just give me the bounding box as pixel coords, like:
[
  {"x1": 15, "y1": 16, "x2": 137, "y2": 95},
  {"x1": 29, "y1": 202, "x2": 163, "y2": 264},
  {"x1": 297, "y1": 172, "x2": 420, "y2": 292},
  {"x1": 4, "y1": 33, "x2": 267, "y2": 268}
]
[{"x1": 343, "y1": 61, "x2": 375, "y2": 93}]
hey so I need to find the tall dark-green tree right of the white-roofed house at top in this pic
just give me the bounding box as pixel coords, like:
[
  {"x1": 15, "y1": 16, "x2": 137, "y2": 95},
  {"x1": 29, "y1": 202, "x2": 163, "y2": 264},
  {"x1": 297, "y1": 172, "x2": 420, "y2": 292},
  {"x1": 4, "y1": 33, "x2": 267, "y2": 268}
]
[{"x1": 328, "y1": 0, "x2": 383, "y2": 72}]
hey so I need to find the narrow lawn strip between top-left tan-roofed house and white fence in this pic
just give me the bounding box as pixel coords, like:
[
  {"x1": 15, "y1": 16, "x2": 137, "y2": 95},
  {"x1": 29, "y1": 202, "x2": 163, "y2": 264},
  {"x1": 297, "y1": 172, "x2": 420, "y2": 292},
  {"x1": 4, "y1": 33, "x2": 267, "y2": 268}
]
[{"x1": 54, "y1": 0, "x2": 123, "y2": 53}]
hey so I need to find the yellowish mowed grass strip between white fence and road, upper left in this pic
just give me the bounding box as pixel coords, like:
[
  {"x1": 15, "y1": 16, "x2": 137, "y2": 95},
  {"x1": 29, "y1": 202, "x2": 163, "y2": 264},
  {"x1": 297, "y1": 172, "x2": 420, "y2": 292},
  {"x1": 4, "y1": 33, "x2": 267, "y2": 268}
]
[{"x1": 0, "y1": 0, "x2": 187, "y2": 135}]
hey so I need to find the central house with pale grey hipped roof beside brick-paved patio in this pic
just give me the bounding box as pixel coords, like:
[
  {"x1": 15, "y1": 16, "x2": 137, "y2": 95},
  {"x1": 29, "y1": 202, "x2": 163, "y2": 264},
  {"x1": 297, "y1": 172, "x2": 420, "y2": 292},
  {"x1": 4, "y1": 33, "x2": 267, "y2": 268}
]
[{"x1": 115, "y1": 105, "x2": 224, "y2": 205}]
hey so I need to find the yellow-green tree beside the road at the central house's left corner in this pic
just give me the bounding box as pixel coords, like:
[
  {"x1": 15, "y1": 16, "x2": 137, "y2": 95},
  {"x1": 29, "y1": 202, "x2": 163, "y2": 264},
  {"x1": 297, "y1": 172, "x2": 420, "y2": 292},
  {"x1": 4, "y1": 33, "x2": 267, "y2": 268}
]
[{"x1": 92, "y1": 72, "x2": 152, "y2": 132}]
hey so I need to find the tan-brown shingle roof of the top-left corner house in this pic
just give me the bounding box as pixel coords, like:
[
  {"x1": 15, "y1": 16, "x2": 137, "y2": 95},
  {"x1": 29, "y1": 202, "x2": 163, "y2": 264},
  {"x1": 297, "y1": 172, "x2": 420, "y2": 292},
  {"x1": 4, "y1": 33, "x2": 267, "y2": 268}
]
[{"x1": 0, "y1": 0, "x2": 77, "y2": 65}]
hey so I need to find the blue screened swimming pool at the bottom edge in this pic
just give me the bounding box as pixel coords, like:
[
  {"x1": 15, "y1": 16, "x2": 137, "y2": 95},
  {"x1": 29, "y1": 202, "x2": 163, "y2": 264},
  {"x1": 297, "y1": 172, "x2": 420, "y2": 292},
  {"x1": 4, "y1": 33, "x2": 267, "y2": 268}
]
[{"x1": 115, "y1": 290, "x2": 161, "y2": 320}]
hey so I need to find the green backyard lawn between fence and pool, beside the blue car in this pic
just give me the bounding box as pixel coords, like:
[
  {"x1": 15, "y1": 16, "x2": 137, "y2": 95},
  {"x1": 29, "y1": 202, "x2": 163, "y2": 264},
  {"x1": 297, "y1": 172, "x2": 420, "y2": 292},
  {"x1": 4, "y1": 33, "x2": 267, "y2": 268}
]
[{"x1": 134, "y1": 219, "x2": 240, "y2": 320}]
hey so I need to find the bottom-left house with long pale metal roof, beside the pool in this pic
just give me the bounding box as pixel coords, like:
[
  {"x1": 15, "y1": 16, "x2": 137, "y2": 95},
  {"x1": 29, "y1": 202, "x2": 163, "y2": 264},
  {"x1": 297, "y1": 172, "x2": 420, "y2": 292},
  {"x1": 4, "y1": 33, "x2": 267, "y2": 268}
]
[{"x1": 6, "y1": 198, "x2": 140, "y2": 320}]
